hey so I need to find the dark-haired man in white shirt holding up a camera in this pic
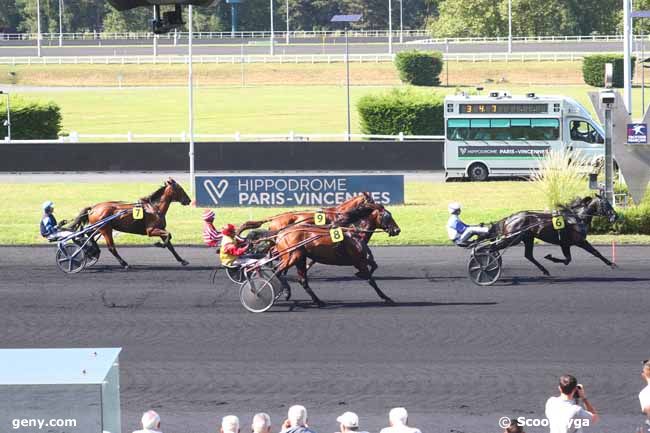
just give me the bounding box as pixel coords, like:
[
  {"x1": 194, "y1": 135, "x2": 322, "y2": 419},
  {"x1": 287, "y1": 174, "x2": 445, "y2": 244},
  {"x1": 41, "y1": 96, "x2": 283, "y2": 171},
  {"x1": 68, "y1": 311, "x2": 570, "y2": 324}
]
[{"x1": 546, "y1": 374, "x2": 598, "y2": 433}]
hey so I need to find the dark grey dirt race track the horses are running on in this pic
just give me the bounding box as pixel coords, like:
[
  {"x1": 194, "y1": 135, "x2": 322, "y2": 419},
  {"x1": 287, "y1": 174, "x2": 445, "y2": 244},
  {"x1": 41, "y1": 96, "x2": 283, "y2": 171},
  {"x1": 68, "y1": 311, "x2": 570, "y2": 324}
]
[{"x1": 0, "y1": 246, "x2": 650, "y2": 433}]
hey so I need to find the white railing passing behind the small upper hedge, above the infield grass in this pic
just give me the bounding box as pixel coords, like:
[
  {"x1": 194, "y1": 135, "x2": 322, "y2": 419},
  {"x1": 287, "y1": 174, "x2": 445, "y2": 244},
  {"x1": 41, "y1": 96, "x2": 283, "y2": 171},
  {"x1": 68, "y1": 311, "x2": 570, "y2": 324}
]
[{"x1": 0, "y1": 52, "x2": 587, "y2": 66}]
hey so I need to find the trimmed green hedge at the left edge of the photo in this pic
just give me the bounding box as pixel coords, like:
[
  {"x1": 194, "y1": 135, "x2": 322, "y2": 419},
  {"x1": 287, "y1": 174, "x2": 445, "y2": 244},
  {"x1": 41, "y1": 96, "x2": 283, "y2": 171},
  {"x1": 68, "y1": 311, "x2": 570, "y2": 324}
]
[{"x1": 0, "y1": 95, "x2": 61, "y2": 140}]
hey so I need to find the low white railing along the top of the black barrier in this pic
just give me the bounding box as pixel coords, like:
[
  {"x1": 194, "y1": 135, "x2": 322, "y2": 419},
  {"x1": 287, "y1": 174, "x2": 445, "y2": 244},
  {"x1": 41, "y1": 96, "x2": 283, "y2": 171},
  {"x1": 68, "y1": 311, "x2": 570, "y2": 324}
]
[{"x1": 10, "y1": 131, "x2": 445, "y2": 146}]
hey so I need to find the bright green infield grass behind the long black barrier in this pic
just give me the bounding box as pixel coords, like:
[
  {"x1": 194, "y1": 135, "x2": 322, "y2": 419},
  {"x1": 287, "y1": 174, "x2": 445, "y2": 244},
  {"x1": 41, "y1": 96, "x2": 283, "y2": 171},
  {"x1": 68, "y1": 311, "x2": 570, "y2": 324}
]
[{"x1": 8, "y1": 85, "x2": 640, "y2": 134}]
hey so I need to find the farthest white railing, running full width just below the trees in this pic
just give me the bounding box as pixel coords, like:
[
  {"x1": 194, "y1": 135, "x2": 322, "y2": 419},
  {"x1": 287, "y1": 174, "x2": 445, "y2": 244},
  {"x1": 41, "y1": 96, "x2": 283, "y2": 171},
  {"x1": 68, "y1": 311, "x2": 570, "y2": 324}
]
[{"x1": 0, "y1": 29, "x2": 650, "y2": 44}]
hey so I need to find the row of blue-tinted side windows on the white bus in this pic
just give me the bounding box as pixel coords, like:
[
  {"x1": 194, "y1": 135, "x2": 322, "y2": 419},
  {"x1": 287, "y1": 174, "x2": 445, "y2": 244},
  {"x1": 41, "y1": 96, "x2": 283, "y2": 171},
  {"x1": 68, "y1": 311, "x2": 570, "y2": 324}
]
[{"x1": 447, "y1": 118, "x2": 560, "y2": 141}]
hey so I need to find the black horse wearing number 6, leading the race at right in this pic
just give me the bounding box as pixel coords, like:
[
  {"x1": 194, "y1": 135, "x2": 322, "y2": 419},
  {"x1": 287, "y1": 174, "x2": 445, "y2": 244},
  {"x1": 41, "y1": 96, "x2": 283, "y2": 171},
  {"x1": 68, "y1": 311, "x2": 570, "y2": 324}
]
[{"x1": 490, "y1": 195, "x2": 617, "y2": 275}]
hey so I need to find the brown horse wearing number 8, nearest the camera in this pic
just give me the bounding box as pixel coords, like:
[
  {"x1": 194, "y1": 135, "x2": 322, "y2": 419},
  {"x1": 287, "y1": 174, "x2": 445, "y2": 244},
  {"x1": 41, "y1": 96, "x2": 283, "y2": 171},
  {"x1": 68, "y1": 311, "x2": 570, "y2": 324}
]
[{"x1": 275, "y1": 205, "x2": 400, "y2": 307}]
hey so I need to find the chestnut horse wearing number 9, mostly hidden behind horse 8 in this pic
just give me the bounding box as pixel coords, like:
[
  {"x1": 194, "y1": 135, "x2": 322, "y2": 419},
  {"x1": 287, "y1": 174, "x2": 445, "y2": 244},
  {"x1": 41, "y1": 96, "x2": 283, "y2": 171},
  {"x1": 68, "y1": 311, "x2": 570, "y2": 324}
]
[{"x1": 237, "y1": 192, "x2": 374, "y2": 235}]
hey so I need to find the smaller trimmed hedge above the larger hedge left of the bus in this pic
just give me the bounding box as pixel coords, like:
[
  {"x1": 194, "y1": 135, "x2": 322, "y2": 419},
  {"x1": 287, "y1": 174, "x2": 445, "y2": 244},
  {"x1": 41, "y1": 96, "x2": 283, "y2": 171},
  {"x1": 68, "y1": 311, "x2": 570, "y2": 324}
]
[{"x1": 395, "y1": 50, "x2": 442, "y2": 86}]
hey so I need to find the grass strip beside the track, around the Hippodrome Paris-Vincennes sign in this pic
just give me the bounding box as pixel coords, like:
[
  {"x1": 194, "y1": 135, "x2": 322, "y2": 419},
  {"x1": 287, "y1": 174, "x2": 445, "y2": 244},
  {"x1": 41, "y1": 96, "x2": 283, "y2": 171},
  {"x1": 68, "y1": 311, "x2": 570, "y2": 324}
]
[{"x1": 0, "y1": 182, "x2": 650, "y2": 245}]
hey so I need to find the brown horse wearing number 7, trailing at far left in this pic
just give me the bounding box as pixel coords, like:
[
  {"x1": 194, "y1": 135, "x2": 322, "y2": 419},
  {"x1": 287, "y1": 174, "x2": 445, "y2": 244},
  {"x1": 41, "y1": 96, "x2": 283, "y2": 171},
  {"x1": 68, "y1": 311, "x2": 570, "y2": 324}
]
[{"x1": 72, "y1": 178, "x2": 191, "y2": 269}]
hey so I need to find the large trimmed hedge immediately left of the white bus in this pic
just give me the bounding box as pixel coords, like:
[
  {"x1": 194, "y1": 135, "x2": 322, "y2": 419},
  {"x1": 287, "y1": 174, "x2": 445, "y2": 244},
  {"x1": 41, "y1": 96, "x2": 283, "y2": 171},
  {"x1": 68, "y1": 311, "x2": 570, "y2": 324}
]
[{"x1": 357, "y1": 88, "x2": 444, "y2": 135}]
